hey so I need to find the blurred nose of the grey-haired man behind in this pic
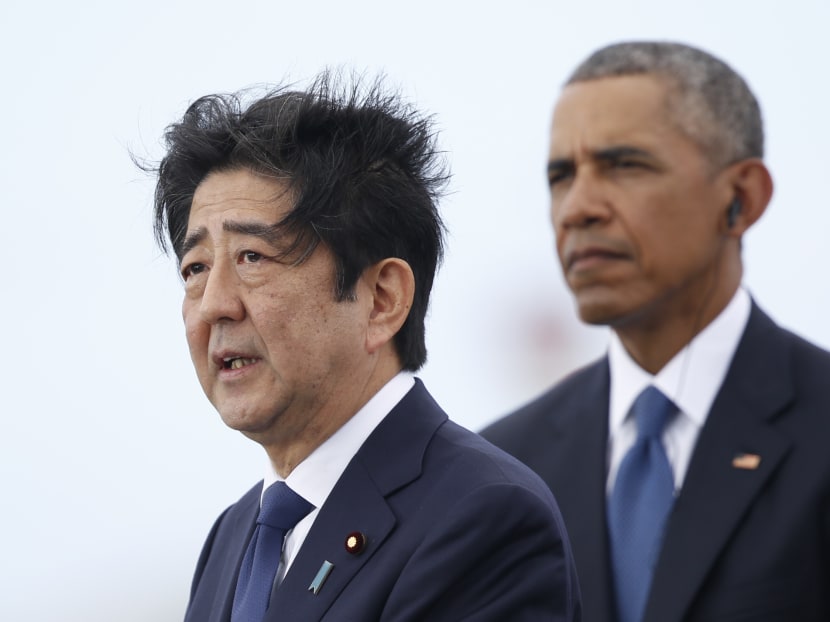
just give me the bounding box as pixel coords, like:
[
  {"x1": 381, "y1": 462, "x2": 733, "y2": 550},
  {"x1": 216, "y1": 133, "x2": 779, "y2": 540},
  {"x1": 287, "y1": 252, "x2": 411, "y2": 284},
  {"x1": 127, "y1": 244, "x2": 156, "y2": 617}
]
[{"x1": 551, "y1": 169, "x2": 611, "y2": 230}]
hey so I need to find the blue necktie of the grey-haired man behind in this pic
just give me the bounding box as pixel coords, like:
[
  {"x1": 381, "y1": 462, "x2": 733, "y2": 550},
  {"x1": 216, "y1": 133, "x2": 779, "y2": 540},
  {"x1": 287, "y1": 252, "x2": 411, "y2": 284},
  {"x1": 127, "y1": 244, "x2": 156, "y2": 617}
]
[{"x1": 608, "y1": 386, "x2": 677, "y2": 622}]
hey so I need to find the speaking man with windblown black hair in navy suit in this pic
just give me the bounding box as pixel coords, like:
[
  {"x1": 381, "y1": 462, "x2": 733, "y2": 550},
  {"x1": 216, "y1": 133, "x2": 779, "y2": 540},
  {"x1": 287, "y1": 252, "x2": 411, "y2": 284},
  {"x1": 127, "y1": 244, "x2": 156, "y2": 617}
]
[{"x1": 150, "y1": 75, "x2": 580, "y2": 622}]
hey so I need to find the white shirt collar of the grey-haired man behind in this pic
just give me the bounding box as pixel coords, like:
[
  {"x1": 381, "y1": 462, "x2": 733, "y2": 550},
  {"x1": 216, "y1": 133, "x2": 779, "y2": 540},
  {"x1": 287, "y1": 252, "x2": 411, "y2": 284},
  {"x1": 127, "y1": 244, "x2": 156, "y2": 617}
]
[{"x1": 608, "y1": 287, "x2": 752, "y2": 436}]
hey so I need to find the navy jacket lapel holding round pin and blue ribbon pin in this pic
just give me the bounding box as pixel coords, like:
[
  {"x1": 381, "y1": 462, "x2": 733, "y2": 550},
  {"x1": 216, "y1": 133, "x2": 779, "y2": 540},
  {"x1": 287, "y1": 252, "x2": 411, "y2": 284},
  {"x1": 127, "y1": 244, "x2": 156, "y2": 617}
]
[{"x1": 265, "y1": 381, "x2": 446, "y2": 622}]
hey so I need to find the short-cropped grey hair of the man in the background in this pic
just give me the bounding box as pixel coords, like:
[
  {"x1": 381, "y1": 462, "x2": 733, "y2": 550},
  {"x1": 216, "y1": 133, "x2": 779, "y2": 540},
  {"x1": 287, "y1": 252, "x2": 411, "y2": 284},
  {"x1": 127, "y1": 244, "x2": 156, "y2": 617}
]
[{"x1": 566, "y1": 41, "x2": 764, "y2": 168}]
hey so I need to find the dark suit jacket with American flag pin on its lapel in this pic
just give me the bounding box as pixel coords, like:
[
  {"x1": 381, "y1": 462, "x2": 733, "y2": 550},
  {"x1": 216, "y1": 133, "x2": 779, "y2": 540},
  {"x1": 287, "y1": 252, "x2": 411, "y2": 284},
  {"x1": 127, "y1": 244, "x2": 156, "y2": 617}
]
[{"x1": 483, "y1": 303, "x2": 830, "y2": 622}]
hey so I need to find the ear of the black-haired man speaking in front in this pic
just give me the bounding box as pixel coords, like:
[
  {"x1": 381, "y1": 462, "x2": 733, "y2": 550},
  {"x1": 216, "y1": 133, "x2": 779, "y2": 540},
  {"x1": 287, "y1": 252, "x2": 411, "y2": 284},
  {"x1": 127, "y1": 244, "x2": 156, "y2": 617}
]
[{"x1": 363, "y1": 257, "x2": 415, "y2": 354}]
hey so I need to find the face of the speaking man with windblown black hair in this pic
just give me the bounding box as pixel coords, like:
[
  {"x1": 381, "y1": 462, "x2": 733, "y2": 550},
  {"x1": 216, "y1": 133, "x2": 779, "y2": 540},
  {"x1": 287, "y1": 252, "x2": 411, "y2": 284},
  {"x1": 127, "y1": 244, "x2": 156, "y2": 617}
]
[{"x1": 181, "y1": 170, "x2": 368, "y2": 444}]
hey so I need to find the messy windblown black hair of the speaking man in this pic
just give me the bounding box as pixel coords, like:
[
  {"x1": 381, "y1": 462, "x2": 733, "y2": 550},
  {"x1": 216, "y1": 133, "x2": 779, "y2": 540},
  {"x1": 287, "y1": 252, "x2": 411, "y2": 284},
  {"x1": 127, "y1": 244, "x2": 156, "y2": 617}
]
[{"x1": 151, "y1": 72, "x2": 449, "y2": 371}]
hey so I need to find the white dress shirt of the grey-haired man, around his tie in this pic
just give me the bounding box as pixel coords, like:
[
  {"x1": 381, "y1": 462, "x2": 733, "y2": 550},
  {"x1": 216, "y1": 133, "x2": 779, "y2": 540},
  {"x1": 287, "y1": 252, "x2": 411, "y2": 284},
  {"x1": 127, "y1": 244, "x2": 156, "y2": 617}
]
[{"x1": 606, "y1": 288, "x2": 751, "y2": 495}]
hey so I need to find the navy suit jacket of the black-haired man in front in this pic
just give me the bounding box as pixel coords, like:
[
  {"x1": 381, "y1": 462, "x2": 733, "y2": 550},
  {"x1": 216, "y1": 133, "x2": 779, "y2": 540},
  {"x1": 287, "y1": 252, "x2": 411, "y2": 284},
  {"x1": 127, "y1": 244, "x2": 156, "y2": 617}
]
[{"x1": 186, "y1": 382, "x2": 580, "y2": 622}]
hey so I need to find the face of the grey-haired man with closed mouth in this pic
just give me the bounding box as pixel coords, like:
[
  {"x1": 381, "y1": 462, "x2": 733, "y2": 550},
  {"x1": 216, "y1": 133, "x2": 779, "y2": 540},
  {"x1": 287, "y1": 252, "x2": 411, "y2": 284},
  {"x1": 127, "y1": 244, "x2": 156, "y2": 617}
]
[{"x1": 548, "y1": 76, "x2": 734, "y2": 327}]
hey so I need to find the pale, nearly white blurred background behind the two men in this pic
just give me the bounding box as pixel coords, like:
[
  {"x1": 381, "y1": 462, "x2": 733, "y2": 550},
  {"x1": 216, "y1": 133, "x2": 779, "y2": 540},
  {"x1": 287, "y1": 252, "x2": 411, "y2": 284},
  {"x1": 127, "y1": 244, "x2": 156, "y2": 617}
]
[{"x1": 0, "y1": 0, "x2": 830, "y2": 622}]
